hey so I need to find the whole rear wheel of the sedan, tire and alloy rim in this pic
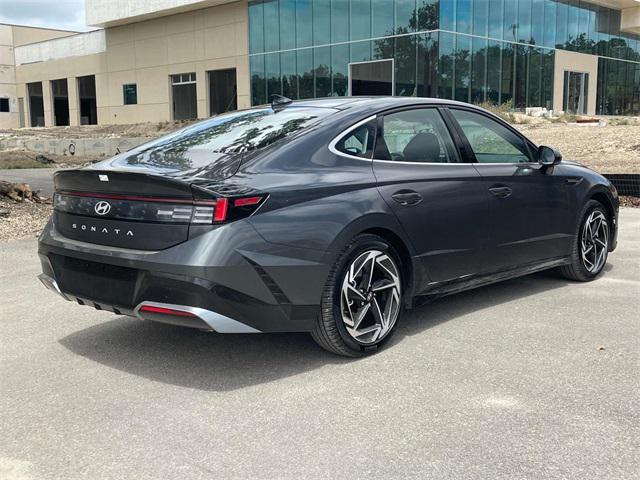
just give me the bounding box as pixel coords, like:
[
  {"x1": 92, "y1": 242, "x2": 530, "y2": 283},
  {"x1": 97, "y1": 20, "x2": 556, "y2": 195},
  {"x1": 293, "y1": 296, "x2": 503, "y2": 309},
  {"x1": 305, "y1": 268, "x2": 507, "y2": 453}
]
[{"x1": 311, "y1": 234, "x2": 402, "y2": 357}]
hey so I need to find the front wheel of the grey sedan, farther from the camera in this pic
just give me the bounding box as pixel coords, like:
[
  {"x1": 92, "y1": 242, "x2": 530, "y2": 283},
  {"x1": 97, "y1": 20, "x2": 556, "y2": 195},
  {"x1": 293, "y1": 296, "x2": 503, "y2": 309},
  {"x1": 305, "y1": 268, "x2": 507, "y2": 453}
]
[{"x1": 560, "y1": 200, "x2": 610, "y2": 282}]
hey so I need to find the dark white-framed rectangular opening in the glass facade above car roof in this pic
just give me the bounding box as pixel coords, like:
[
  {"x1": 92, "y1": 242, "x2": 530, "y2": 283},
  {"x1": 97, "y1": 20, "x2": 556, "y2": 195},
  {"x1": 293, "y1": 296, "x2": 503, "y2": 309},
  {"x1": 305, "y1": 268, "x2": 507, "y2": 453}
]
[{"x1": 349, "y1": 58, "x2": 395, "y2": 96}]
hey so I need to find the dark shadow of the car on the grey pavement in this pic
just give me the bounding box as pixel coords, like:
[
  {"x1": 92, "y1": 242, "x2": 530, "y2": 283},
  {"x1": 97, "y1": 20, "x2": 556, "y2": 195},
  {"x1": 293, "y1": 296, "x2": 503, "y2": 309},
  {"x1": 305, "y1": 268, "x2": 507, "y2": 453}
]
[{"x1": 60, "y1": 273, "x2": 568, "y2": 391}]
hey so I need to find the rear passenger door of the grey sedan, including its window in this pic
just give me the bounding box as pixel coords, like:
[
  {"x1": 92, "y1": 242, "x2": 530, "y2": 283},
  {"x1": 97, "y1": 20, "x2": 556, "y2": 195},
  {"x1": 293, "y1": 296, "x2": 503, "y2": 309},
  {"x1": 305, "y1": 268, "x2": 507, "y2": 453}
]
[{"x1": 373, "y1": 107, "x2": 488, "y2": 292}]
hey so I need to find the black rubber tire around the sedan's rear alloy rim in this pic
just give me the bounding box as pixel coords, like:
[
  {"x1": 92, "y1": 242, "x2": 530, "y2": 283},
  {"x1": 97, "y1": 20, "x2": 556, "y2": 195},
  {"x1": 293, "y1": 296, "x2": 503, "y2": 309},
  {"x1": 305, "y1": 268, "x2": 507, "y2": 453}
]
[{"x1": 311, "y1": 234, "x2": 403, "y2": 357}]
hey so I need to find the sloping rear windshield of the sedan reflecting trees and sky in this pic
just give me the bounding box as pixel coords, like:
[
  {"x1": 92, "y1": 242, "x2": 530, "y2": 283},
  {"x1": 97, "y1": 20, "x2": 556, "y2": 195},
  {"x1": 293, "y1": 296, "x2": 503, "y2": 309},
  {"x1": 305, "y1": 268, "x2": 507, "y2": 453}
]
[{"x1": 117, "y1": 106, "x2": 336, "y2": 170}]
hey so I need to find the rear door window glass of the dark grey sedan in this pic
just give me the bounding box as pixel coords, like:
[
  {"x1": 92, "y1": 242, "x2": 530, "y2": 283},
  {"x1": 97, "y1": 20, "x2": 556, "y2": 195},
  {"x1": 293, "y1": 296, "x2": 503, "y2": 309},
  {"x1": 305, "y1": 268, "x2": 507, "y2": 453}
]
[{"x1": 376, "y1": 108, "x2": 458, "y2": 163}]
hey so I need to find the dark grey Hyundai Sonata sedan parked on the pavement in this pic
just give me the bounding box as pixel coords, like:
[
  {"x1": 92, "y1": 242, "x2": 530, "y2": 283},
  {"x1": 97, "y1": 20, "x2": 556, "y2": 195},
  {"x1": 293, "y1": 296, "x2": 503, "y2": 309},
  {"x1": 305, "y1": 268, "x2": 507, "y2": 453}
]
[{"x1": 39, "y1": 97, "x2": 618, "y2": 356}]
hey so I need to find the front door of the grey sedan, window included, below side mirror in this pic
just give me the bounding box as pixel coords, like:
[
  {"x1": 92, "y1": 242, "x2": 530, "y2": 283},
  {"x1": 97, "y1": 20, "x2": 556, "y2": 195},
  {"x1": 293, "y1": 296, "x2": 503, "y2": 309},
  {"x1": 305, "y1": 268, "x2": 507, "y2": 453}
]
[{"x1": 449, "y1": 107, "x2": 572, "y2": 271}]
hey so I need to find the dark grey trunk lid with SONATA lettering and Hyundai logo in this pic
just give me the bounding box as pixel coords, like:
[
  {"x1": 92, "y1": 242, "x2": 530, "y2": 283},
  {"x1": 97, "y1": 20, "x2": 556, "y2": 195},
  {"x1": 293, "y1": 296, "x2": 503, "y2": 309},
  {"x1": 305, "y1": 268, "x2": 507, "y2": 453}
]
[{"x1": 54, "y1": 169, "x2": 216, "y2": 250}]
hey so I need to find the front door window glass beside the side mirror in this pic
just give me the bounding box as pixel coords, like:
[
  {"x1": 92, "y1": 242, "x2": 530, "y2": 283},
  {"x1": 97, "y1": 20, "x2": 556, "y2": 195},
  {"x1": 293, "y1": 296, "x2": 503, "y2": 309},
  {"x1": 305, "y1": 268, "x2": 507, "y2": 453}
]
[{"x1": 451, "y1": 109, "x2": 531, "y2": 163}]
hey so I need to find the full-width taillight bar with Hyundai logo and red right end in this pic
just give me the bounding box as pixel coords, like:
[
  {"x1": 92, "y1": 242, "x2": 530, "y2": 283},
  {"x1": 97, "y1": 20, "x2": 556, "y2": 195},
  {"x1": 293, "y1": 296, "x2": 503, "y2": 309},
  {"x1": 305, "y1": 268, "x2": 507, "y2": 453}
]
[{"x1": 53, "y1": 192, "x2": 267, "y2": 225}]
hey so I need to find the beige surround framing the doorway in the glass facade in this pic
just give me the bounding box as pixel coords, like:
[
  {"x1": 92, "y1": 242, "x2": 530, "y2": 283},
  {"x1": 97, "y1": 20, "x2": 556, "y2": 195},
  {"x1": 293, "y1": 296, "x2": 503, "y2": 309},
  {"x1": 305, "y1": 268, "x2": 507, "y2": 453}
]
[{"x1": 553, "y1": 50, "x2": 598, "y2": 115}]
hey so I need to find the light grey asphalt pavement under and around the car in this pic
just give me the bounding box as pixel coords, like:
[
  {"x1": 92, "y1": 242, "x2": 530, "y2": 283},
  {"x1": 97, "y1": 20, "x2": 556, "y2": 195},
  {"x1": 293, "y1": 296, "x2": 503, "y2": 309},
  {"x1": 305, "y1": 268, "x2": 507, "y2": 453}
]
[{"x1": 0, "y1": 209, "x2": 640, "y2": 480}]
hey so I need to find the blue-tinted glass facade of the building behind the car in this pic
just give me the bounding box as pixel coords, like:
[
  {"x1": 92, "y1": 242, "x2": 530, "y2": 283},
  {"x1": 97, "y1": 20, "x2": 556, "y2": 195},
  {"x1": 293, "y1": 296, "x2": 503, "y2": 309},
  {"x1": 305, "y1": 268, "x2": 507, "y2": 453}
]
[{"x1": 249, "y1": 0, "x2": 640, "y2": 115}]
